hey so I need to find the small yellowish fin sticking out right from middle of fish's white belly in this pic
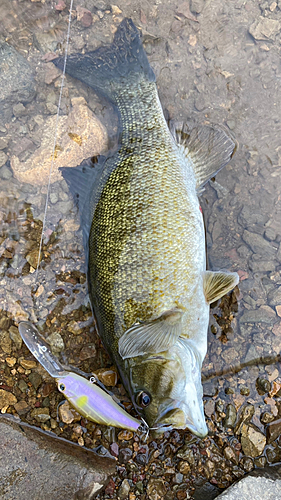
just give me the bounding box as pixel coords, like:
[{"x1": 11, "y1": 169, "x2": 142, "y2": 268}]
[{"x1": 203, "y1": 271, "x2": 239, "y2": 304}]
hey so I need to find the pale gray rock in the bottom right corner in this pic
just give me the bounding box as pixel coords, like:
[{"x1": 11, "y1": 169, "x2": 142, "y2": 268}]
[{"x1": 216, "y1": 465, "x2": 281, "y2": 500}]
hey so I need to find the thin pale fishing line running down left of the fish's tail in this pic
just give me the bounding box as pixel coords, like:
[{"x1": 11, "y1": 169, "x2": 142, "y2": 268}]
[{"x1": 35, "y1": 0, "x2": 73, "y2": 284}]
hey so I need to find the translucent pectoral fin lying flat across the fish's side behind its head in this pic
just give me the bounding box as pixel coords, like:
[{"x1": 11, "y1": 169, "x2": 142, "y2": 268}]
[{"x1": 119, "y1": 309, "x2": 183, "y2": 359}]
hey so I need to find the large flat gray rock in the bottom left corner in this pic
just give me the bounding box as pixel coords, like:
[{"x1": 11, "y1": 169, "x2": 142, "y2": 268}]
[{"x1": 0, "y1": 415, "x2": 115, "y2": 500}]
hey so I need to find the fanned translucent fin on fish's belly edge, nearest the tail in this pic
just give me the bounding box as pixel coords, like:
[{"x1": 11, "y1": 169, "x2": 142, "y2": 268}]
[{"x1": 173, "y1": 125, "x2": 234, "y2": 191}]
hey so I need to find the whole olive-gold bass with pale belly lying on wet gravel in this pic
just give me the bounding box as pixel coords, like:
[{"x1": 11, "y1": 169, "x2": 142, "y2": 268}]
[{"x1": 53, "y1": 19, "x2": 238, "y2": 437}]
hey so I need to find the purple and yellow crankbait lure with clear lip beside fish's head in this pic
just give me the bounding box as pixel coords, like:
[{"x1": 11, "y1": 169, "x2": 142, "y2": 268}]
[{"x1": 19, "y1": 321, "x2": 144, "y2": 431}]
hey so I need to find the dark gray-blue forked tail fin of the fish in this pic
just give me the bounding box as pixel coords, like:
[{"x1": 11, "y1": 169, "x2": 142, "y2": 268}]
[{"x1": 52, "y1": 18, "x2": 155, "y2": 103}]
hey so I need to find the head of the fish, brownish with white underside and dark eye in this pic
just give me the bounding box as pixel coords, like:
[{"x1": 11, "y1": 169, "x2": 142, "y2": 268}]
[{"x1": 124, "y1": 339, "x2": 208, "y2": 438}]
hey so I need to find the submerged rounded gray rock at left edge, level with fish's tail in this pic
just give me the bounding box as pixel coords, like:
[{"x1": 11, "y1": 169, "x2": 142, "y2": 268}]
[{"x1": 0, "y1": 41, "x2": 35, "y2": 121}]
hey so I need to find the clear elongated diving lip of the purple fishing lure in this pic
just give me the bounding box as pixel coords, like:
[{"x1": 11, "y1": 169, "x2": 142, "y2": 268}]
[{"x1": 18, "y1": 321, "x2": 68, "y2": 378}]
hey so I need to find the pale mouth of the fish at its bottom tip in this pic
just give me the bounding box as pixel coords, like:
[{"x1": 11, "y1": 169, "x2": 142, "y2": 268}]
[{"x1": 153, "y1": 408, "x2": 208, "y2": 439}]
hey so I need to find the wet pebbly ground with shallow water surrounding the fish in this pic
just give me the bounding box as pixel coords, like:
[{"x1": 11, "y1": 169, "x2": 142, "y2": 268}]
[{"x1": 0, "y1": 0, "x2": 281, "y2": 500}]
